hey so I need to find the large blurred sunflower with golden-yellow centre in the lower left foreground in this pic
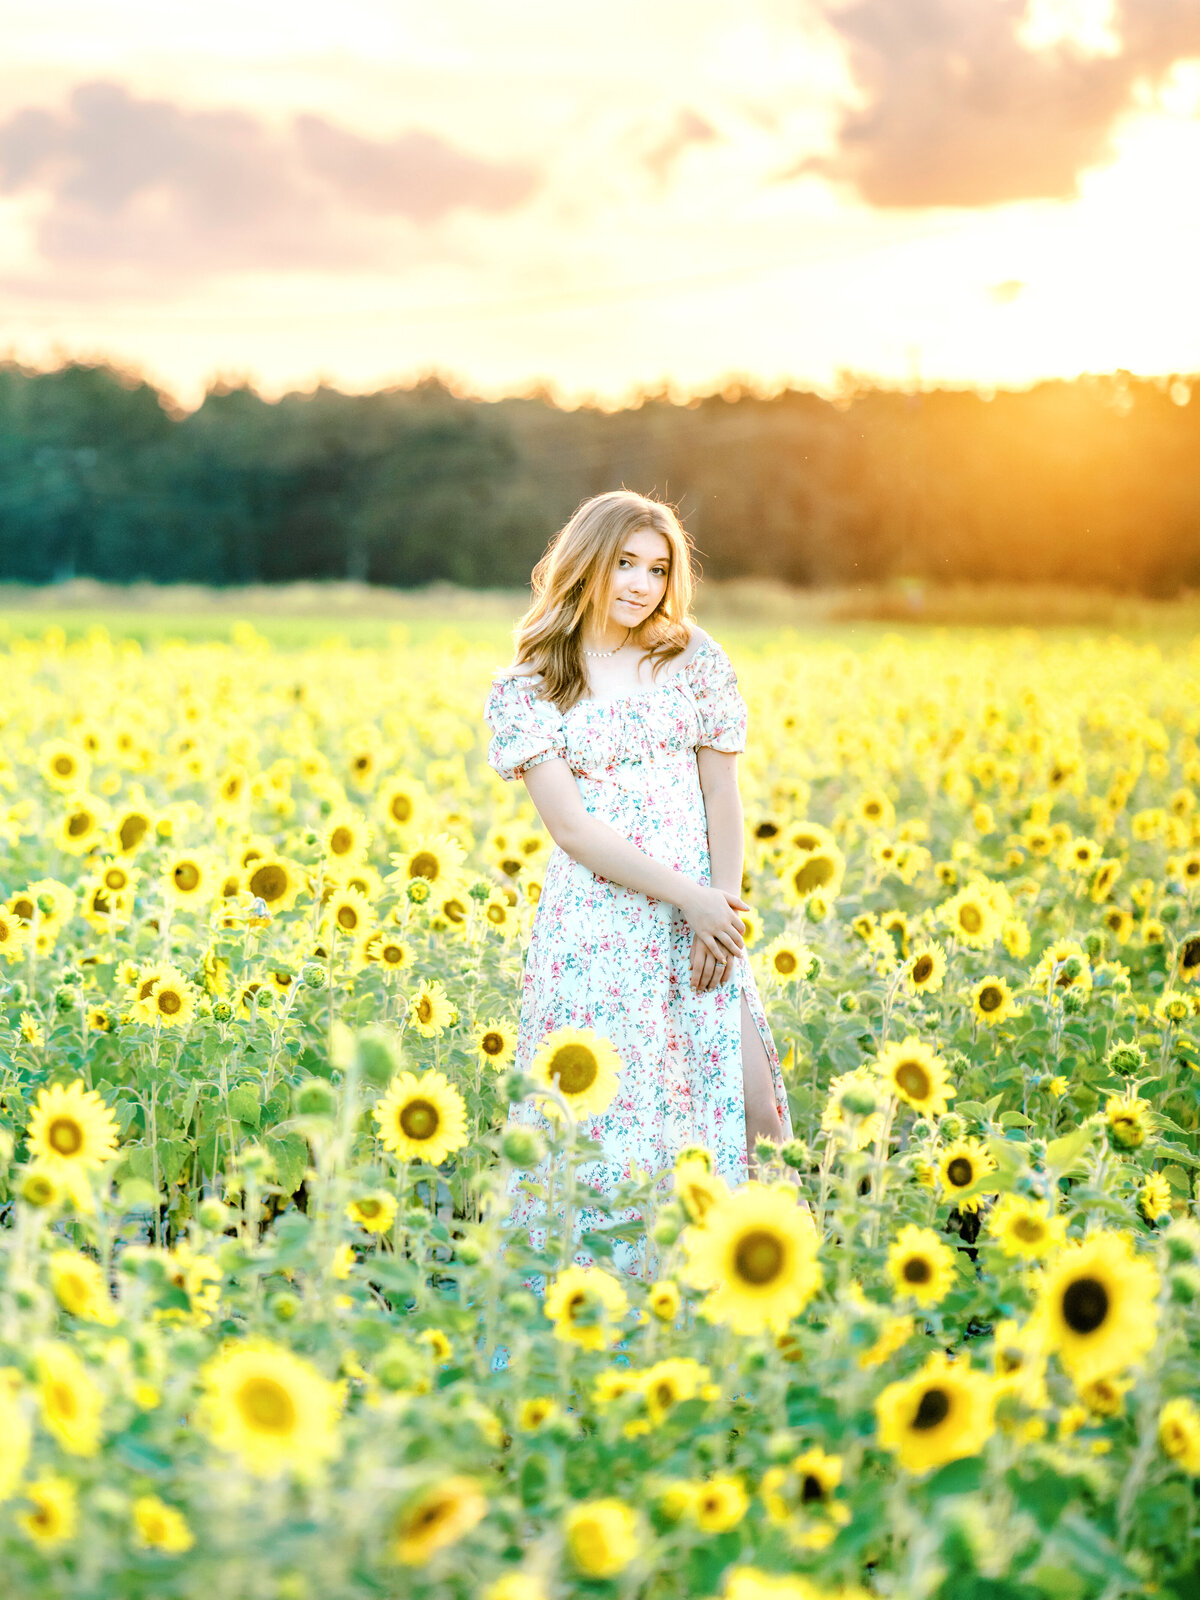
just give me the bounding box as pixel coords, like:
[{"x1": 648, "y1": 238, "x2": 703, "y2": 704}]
[{"x1": 198, "y1": 1339, "x2": 341, "y2": 1478}]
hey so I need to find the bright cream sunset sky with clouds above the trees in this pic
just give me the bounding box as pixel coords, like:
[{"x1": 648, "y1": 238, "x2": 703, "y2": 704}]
[{"x1": 0, "y1": 0, "x2": 1200, "y2": 406}]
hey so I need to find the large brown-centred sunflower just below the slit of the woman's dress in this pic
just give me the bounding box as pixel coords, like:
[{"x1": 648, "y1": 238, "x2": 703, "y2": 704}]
[{"x1": 683, "y1": 1179, "x2": 822, "y2": 1333}]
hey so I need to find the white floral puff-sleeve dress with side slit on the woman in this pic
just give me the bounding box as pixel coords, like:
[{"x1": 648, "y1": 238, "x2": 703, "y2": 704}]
[{"x1": 483, "y1": 634, "x2": 792, "y2": 1277}]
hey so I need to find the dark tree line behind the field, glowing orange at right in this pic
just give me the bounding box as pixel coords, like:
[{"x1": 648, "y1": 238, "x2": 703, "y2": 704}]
[{"x1": 0, "y1": 362, "x2": 1200, "y2": 595}]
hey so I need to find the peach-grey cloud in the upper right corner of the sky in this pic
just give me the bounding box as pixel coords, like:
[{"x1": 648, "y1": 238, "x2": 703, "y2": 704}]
[{"x1": 800, "y1": 0, "x2": 1200, "y2": 206}]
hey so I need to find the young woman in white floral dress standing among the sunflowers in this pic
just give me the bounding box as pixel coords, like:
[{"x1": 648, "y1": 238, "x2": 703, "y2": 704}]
[{"x1": 483, "y1": 490, "x2": 792, "y2": 1275}]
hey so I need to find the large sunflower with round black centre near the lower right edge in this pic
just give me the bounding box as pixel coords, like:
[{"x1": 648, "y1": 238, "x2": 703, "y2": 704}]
[{"x1": 1034, "y1": 1230, "x2": 1158, "y2": 1384}]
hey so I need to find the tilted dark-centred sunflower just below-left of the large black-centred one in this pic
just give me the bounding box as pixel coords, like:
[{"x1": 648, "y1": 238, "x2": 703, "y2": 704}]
[{"x1": 875, "y1": 1350, "x2": 994, "y2": 1472}]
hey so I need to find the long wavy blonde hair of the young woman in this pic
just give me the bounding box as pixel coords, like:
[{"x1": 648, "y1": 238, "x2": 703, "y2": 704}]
[{"x1": 496, "y1": 490, "x2": 696, "y2": 712}]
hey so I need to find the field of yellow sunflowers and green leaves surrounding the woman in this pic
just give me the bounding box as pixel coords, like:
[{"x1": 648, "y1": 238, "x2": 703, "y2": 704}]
[{"x1": 0, "y1": 624, "x2": 1200, "y2": 1600}]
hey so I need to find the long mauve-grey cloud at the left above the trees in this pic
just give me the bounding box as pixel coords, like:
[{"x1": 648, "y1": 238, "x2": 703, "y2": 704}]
[{"x1": 0, "y1": 82, "x2": 538, "y2": 277}]
